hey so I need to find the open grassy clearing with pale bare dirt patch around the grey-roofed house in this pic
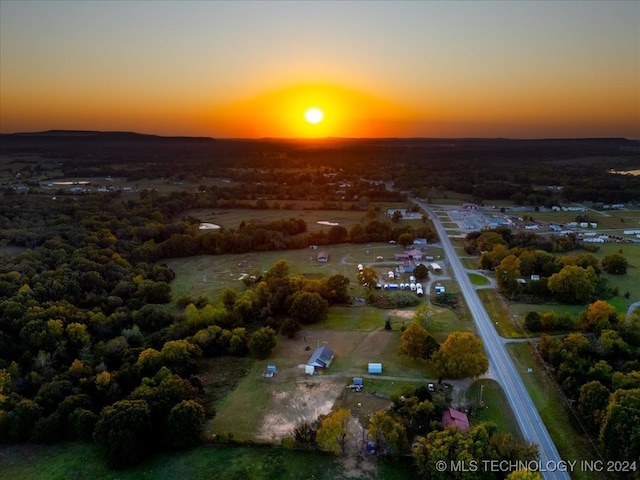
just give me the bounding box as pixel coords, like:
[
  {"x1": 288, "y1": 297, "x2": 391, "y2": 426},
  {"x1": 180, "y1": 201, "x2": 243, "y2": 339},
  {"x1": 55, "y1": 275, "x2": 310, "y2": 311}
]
[{"x1": 206, "y1": 329, "x2": 434, "y2": 441}]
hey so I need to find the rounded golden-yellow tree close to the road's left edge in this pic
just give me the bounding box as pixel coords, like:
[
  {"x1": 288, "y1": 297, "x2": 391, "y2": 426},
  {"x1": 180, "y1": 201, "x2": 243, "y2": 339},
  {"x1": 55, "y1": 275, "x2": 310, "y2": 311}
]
[{"x1": 431, "y1": 332, "x2": 489, "y2": 378}]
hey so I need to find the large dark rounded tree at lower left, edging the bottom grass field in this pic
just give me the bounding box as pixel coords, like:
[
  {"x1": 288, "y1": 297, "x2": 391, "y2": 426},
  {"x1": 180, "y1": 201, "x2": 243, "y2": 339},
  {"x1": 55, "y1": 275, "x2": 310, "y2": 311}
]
[{"x1": 93, "y1": 400, "x2": 153, "y2": 468}]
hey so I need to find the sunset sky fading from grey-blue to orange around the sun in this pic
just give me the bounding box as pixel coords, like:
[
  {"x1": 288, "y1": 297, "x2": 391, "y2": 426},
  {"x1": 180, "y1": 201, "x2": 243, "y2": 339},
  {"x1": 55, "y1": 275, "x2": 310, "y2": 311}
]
[{"x1": 0, "y1": 0, "x2": 640, "y2": 138}]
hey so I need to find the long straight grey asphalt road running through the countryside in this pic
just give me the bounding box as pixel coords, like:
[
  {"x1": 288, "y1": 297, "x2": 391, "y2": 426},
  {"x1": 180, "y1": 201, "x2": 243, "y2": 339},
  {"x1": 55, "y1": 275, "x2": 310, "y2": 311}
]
[{"x1": 414, "y1": 200, "x2": 568, "y2": 480}]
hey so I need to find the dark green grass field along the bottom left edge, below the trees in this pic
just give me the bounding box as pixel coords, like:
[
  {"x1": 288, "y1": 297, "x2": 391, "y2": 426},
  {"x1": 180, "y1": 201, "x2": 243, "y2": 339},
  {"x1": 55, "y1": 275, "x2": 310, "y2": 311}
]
[{"x1": 0, "y1": 443, "x2": 364, "y2": 480}]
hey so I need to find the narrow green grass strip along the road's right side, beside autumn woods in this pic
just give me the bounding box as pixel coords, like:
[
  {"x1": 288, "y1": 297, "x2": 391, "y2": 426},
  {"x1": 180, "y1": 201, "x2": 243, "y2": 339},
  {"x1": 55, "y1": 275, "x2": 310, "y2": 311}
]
[{"x1": 506, "y1": 342, "x2": 604, "y2": 480}]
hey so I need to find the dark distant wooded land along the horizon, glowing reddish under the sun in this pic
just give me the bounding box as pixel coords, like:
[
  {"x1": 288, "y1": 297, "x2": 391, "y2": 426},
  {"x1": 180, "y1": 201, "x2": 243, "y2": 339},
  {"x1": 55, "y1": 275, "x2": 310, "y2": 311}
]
[{"x1": 0, "y1": 132, "x2": 640, "y2": 206}]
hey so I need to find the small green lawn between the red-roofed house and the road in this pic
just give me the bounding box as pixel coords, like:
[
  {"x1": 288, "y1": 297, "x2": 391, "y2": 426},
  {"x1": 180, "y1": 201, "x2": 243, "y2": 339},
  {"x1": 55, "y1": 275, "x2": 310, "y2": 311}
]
[{"x1": 465, "y1": 379, "x2": 521, "y2": 438}]
